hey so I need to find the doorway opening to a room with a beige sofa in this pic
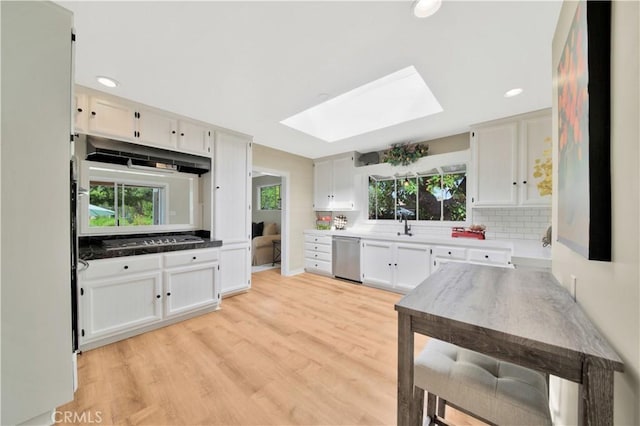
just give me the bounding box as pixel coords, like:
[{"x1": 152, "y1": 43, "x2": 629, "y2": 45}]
[{"x1": 251, "y1": 167, "x2": 289, "y2": 275}]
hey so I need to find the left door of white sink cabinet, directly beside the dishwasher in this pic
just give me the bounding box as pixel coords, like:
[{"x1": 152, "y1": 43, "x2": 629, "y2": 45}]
[{"x1": 360, "y1": 241, "x2": 393, "y2": 288}]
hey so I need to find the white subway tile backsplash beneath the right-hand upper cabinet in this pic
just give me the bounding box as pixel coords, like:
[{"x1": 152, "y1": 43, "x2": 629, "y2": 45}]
[{"x1": 473, "y1": 207, "x2": 551, "y2": 240}]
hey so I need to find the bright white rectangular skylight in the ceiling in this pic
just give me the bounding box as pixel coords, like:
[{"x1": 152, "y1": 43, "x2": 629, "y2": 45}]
[{"x1": 280, "y1": 65, "x2": 442, "y2": 142}]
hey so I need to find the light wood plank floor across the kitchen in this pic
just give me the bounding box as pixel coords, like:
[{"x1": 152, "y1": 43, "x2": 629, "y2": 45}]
[{"x1": 59, "y1": 269, "x2": 480, "y2": 425}]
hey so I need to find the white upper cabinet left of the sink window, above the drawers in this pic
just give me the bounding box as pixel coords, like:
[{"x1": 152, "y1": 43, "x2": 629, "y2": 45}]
[{"x1": 313, "y1": 154, "x2": 355, "y2": 210}]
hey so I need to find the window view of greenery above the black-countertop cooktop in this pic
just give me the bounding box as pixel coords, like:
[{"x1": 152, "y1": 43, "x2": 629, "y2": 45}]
[{"x1": 89, "y1": 181, "x2": 166, "y2": 227}]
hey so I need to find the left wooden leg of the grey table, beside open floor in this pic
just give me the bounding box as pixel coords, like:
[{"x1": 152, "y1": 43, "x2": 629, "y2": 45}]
[{"x1": 398, "y1": 312, "x2": 422, "y2": 426}]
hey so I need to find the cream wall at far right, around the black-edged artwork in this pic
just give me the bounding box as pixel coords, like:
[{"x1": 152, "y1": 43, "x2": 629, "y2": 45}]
[{"x1": 552, "y1": 1, "x2": 640, "y2": 425}]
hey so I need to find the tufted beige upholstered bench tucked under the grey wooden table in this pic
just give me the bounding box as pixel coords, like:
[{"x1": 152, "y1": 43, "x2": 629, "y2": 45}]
[{"x1": 414, "y1": 339, "x2": 551, "y2": 425}]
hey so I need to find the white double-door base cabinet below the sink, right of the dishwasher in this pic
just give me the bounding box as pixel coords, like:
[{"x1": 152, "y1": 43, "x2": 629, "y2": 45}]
[{"x1": 360, "y1": 240, "x2": 431, "y2": 293}]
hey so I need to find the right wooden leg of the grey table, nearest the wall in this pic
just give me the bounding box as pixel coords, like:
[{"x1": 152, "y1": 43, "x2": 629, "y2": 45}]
[{"x1": 578, "y1": 361, "x2": 613, "y2": 426}]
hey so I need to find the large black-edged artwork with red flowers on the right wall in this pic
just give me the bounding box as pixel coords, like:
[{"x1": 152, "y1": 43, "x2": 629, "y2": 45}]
[{"x1": 557, "y1": 0, "x2": 611, "y2": 261}]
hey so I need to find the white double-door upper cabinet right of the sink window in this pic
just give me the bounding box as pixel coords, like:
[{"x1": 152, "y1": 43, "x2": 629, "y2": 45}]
[{"x1": 471, "y1": 110, "x2": 551, "y2": 207}]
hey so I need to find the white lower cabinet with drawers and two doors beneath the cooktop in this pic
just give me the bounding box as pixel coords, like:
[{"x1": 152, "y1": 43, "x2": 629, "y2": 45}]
[{"x1": 78, "y1": 248, "x2": 220, "y2": 349}]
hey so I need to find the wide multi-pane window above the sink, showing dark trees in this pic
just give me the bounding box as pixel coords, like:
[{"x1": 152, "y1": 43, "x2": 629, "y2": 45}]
[{"x1": 369, "y1": 164, "x2": 467, "y2": 222}]
